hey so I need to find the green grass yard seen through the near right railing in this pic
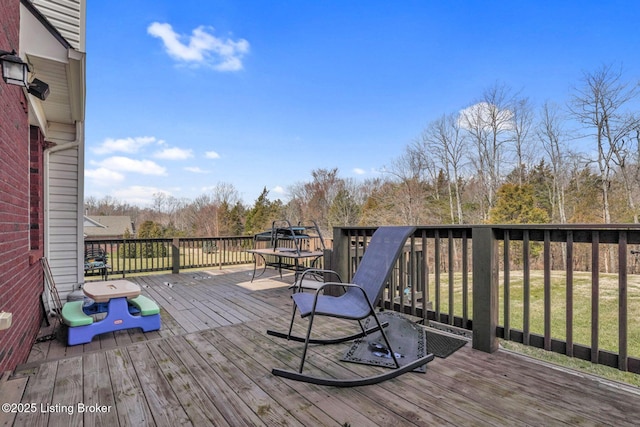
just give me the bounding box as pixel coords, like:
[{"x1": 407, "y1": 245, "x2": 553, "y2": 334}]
[{"x1": 429, "y1": 270, "x2": 640, "y2": 386}]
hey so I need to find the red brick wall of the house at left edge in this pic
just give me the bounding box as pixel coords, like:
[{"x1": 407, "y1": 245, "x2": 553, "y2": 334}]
[{"x1": 0, "y1": 0, "x2": 44, "y2": 372}]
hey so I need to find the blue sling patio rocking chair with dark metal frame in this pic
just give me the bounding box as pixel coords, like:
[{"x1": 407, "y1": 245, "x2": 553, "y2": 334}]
[{"x1": 267, "y1": 227, "x2": 433, "y2": 387}]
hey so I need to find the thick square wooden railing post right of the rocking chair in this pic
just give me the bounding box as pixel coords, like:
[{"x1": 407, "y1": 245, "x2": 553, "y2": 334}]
[{"x1": 471, "y1": 227, "x2": 499, "y2": 353}]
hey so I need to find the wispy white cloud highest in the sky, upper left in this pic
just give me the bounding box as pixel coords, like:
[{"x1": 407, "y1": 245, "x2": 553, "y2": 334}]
[{"x1": 147, "y1": 22, "x2": 249, "y2": 71}]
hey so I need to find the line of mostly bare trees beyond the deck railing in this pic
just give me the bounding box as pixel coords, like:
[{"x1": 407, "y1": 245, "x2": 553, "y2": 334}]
[{"x1": 85, "y1": 65, "x2": 640, "y2": 237}]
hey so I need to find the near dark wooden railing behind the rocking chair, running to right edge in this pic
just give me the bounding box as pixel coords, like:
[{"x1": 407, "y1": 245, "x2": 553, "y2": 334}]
[{"x1": 330, "y1": 225, "x2": 640, "y2": 373}]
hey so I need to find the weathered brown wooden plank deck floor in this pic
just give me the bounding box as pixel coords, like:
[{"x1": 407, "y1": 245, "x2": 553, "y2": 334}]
[{"x1": 0, "y1": 269, "x2": 640, "y2": 427}]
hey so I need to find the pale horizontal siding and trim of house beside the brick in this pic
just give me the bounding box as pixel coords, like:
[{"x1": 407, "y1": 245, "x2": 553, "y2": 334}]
[{"x1": 22, "y1": 0, "x2": 86, "y2": 310}]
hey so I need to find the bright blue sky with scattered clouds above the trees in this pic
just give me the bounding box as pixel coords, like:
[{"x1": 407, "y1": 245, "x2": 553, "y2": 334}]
[{"x1": 85, "y1": 0, "x2": 640, "y2": 206}]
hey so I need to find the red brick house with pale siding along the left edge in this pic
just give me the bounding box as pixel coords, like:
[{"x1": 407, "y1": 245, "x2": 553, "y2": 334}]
[{"x1": 0, "y1": 0, "x2": 86, "y2": 372}]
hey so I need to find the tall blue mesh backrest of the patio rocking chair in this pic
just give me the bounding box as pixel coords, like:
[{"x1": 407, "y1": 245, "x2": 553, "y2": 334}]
[{"x1": 348, "y1": 226, "x2": 416, "y2": 305}]
